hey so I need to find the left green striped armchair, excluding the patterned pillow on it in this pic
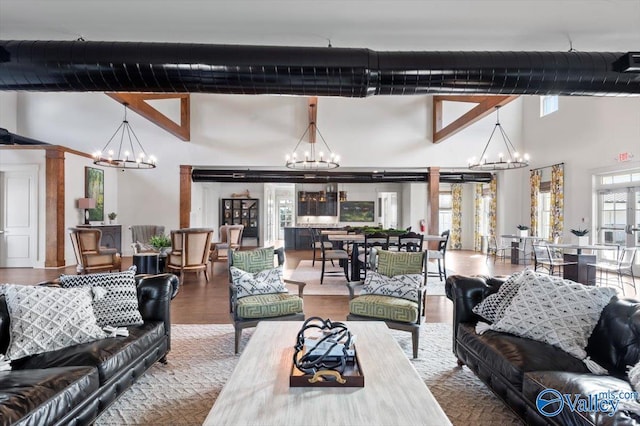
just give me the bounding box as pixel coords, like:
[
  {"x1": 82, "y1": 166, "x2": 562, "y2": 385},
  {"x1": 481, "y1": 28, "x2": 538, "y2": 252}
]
[{"x1": 229, "y1": 247, "x2": 306, "y2": 353}]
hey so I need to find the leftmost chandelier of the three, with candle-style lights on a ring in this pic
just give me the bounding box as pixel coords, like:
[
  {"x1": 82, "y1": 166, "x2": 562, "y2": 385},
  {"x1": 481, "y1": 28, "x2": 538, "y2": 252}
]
[{"x1": 93, "y1": 103, "x2": 156, "y2": 169}]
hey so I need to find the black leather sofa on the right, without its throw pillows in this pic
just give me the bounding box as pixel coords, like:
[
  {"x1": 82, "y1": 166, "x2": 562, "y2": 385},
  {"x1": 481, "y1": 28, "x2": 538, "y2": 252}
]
[{"x1": 445, "y1": 275, "x2": 640, "y2": 425}]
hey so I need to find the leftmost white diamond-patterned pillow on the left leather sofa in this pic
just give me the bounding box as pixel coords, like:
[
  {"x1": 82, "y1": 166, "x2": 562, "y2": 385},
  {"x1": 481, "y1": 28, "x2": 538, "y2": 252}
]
[{"x1": 4, "y1": 284, "x2": 107, "y2": 360}]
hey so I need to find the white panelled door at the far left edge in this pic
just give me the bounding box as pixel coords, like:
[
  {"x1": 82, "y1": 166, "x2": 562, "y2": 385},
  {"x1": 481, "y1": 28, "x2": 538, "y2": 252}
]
[{"x1": 0, "y1": 166, "x2": 38, "y2": 268}]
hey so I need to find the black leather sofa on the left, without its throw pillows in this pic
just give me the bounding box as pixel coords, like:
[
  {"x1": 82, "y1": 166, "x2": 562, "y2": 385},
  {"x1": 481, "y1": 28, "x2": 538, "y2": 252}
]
[{"x1": 0, "y1": 274, "x2": 179, "y2": 425}]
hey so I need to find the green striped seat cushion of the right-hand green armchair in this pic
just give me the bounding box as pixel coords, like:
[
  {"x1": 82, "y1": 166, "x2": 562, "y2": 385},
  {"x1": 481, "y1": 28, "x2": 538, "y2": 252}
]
[{"x1": 349, "y1": 294, "x2": 418, "y2": 323}]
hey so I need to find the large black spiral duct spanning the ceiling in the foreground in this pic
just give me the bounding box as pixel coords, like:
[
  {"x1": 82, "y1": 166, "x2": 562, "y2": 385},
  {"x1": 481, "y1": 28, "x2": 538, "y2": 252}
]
[{"x1": 0, "y1": 40, "x2": 640, "y2": 97}]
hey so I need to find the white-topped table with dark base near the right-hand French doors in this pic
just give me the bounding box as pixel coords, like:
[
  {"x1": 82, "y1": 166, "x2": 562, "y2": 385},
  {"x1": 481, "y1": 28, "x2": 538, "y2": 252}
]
[{"x1": 548, "y1": 243, "x2": 619, "y2": 285}]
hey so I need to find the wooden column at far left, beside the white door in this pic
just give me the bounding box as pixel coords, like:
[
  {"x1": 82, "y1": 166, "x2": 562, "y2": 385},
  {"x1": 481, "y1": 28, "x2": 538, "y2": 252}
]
[{"x1": 44, "y1": 147, "x2": 66, "y2": 267}]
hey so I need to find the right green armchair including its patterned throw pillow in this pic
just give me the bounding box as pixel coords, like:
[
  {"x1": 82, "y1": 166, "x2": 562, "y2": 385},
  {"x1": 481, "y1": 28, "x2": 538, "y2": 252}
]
[{"x1": 347, "y1": 250, "x2": 428, "y2": 358}]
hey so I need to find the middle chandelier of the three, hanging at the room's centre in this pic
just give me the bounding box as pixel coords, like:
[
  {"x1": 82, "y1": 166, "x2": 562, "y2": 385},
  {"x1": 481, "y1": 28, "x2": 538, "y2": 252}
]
[{"x1": 286, "y1": 97, "x2": 340, "y2": 170}]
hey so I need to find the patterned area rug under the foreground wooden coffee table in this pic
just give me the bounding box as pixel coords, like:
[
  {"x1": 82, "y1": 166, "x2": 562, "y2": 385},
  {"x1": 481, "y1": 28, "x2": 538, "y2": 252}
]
[{"x1": 95, "y1": 323, "x2": 522, "y2": 426}]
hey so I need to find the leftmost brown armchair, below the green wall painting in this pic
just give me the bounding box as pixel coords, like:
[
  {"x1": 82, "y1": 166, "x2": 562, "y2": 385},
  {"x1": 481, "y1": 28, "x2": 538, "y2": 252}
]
[{"x1": 69, "y1": 228, "x2": 122, "y2": 274}]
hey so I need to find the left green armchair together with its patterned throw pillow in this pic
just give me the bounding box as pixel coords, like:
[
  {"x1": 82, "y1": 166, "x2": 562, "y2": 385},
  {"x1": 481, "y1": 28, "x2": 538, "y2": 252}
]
[{"x1": 229, "y1": 247, "x2": 306, "y2": 353}]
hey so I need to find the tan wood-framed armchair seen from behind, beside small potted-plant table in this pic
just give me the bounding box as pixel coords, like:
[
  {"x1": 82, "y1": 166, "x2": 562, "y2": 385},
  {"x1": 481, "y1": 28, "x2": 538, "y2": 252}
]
[{"x1": 166, "y1": 228, "x2": 213, "y2": 282}]
